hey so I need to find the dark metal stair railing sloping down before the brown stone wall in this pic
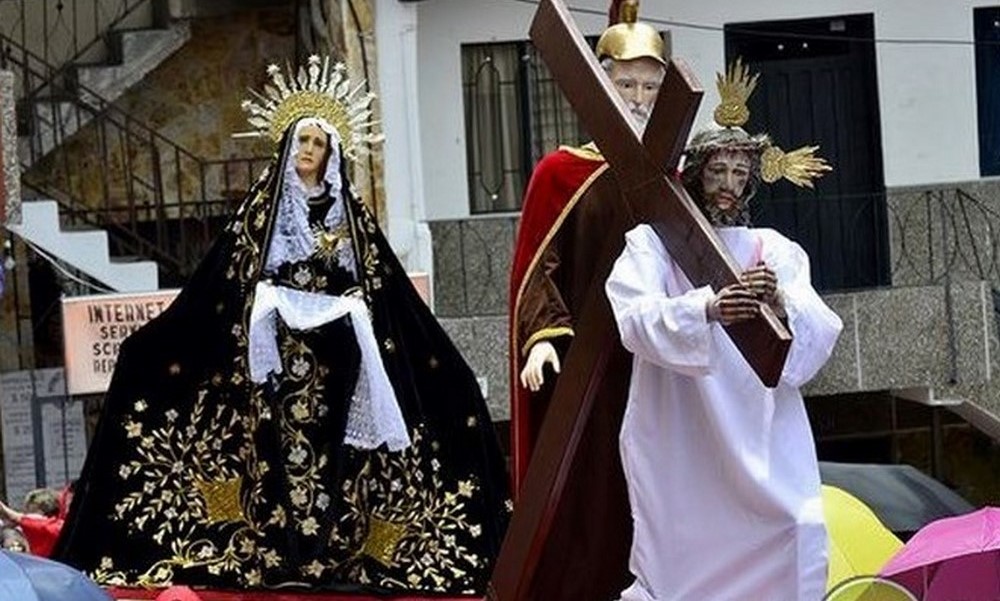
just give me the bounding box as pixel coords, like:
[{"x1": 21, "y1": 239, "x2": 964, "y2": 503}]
[{"x1": 0, "y1": 28, "x2": 267, "y2": 282}]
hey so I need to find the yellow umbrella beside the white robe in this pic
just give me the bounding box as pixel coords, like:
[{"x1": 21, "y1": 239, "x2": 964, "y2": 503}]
[{"x1": 823, "y1": 484, "x2": 903, "y2": 592}]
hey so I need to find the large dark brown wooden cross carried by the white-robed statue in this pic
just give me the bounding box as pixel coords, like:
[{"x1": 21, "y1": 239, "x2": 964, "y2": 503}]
[{"x1": 490, "y1": 0, "x2": 791, "y2": 601}]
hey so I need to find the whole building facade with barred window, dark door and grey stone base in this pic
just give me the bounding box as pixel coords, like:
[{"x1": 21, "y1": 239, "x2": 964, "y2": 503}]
[{"x1": 377, "y1": 0, "x2": 1000, "y2": 454}]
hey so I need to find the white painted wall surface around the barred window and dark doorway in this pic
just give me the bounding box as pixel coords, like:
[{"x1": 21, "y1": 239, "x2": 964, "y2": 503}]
[{"x1": 378, "y1": 0, "x2": 992, "y2": 232}]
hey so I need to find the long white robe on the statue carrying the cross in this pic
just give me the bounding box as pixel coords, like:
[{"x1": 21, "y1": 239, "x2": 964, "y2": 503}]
[{"x1": 606, "y1": 225, "x2": 842, "y2": 601}]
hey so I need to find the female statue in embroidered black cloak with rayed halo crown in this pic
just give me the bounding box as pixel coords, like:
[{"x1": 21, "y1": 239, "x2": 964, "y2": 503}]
[{"x1": 56, "y1": 57, "x2": 509, "y2": 594}]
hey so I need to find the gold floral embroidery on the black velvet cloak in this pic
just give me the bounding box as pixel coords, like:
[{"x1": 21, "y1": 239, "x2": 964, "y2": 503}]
[{"x1": 92, "y1": 180, "x2": 492, "y2": 593}]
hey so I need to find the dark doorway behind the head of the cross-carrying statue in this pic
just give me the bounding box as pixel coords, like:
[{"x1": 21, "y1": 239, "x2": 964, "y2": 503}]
[{"x1": 725, "y1": 15, "x2": 890, "y2": 291}]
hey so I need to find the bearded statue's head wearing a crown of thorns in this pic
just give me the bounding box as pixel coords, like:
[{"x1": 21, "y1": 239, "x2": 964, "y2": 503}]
[{"x1": 681, "y1": 127, "x2": 769, "y2": 226}]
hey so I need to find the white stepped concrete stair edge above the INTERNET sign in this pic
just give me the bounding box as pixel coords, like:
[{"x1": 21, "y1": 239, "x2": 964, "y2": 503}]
[{"x1": 8, "y1": 200, "x2": 160, "y2": 292}]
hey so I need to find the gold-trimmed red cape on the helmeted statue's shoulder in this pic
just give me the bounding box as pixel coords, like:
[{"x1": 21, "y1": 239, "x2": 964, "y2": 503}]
[{"x1": 508, "y1": 150, "x2": 604, "y2": 499}]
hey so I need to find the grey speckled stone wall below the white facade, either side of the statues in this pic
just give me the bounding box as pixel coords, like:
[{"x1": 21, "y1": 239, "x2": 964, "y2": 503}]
[{"x1": 430, "y1": 193, "x2": 1000, "y2": 426}]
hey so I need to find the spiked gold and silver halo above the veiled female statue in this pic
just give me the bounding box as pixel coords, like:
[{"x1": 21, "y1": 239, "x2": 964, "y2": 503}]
[{"x1": 242, "y1": 54, "x2": 383, "y2": 159}]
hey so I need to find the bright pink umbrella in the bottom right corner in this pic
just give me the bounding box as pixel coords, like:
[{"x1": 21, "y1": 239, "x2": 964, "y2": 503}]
[{"x1": 880, "y1": 507, "x2": 1000, "y2": 601}]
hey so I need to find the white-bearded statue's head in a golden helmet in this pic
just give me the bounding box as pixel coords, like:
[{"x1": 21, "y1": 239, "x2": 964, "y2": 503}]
[{"x1": 595, "y1": 0, "x2": 668, "y2": 128}]
